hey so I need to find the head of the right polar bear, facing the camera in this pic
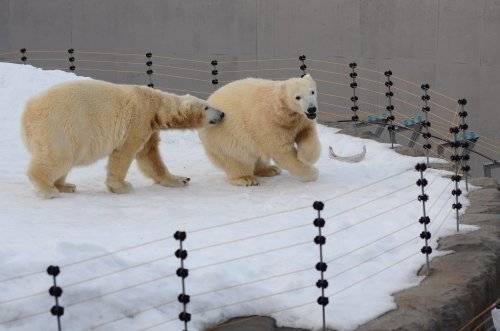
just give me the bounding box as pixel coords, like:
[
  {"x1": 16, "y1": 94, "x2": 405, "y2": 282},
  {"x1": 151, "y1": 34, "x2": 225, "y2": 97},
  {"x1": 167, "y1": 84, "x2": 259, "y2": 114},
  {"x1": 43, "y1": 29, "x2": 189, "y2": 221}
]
[{"x1": 282, "y1": 74, "x2": 318, "y2": 120}]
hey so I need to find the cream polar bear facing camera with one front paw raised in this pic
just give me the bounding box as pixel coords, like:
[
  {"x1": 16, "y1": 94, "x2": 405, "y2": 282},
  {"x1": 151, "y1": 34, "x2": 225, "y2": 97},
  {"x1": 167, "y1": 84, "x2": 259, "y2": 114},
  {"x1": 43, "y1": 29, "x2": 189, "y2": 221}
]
[{"x1": 199, "y1": 75, "x2": 321, "y2": 186}]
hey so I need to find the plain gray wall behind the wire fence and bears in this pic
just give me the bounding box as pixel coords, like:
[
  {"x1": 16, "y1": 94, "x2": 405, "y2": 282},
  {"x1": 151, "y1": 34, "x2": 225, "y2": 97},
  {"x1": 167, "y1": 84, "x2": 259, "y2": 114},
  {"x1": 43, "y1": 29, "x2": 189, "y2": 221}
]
[{"x1": 0, "y1": 0, "x2": 500, "y2": 178}]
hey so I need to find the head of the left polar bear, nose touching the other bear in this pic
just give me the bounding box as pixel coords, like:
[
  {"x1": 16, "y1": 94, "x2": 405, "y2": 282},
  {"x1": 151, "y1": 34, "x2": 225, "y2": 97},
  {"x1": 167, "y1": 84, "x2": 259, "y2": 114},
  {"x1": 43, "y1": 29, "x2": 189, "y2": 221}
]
[{"x1": 156, "y1": 94, "x2": 224, "y2": 129}]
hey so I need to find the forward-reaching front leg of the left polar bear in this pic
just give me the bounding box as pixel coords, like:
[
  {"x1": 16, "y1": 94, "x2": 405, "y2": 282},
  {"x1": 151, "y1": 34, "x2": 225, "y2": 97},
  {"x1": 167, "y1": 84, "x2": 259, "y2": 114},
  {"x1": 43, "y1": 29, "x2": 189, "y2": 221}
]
[{"x1": 136, "y1": 132, "x2": 191, "y2": 187}]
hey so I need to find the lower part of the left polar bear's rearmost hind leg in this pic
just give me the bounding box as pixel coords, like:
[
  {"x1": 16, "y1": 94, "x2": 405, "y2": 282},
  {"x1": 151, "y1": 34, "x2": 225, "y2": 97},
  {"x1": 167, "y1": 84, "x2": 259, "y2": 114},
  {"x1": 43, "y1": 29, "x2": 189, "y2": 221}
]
[{"x1": 27, "y1": 158, "x2": 59, "y2": 199}]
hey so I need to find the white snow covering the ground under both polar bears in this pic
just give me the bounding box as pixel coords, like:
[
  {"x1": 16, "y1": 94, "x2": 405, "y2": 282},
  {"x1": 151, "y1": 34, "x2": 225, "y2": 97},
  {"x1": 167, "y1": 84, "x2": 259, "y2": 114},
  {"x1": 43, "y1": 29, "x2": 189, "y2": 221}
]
[{"x1": 0, "y1": 63, "x2": 473, "y2": 331}]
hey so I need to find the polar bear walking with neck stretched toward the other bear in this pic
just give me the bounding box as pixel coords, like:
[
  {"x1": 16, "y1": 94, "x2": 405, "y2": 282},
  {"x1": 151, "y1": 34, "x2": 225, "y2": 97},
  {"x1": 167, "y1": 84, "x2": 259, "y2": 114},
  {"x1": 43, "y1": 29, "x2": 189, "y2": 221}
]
[{"x1": 21, "y1": 80, "x2": 224, "y2": 198}]
